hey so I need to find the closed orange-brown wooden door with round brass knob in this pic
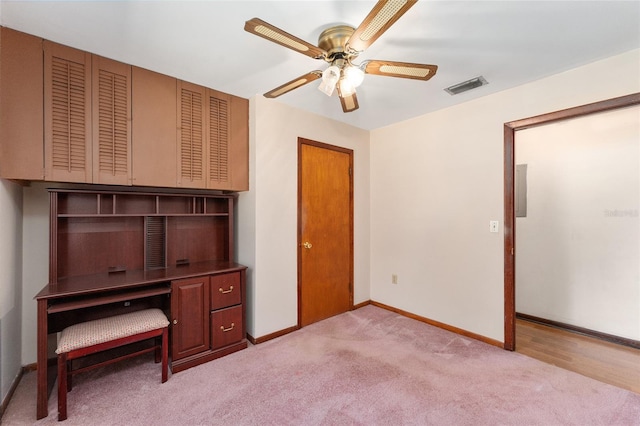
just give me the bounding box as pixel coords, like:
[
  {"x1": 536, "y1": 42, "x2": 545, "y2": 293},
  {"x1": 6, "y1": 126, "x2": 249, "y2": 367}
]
[{"x1": 298, "y1": 138, "x2": 353, "y2": 327}]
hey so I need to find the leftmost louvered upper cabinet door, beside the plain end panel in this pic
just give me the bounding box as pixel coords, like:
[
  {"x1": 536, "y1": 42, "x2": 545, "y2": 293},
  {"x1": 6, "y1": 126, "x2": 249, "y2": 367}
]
[{"x1": 43, "y1": 40, "x2": 92, "y2": 183}]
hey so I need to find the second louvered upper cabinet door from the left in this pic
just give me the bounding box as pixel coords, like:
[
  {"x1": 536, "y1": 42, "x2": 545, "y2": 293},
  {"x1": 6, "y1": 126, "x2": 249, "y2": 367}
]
[{"x1": 92, "y1": 55, "x2": 131, "y2": 185}]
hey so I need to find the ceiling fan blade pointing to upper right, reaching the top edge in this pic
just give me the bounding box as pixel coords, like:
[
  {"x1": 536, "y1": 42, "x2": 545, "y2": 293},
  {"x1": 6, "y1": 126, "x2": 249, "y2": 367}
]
[{"x1": 346, "y1": 0, "x2": 418, "y2": 53}]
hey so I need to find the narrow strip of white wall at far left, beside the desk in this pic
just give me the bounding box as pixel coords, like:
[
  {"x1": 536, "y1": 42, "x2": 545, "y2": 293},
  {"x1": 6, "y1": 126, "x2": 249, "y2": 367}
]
[{"x1": 0, "y1": 179, "x2": 23, "y2": 402}]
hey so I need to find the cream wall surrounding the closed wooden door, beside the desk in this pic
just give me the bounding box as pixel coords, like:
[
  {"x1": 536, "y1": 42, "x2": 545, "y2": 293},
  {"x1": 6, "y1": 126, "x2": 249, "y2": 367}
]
[{"x1": 237, "y1": 96, "x2": 369, "y2": 338}]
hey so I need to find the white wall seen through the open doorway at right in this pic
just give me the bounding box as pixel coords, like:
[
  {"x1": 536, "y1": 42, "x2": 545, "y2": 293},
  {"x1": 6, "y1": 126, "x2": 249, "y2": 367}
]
[{"x1": 515, "y1": 106, "x2": 640, "y2": 340}]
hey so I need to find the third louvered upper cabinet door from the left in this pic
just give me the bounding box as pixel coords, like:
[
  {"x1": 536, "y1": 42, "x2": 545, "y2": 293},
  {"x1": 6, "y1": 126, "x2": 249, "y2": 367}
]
[{"x1": 177, "y1": 81, "x2": 207, "y2": 188}]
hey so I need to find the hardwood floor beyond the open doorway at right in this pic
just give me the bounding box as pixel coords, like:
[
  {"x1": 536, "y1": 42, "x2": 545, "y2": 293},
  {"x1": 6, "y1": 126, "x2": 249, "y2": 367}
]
[{"x1": 516, "y1": 319, "x2": 640, "y2": 394}]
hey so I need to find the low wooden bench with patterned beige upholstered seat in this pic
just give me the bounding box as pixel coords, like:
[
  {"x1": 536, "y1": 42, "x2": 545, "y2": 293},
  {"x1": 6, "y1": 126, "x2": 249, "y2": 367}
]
[{"x1": 56, "y1": 309, "x2": 169, "y2": 420}]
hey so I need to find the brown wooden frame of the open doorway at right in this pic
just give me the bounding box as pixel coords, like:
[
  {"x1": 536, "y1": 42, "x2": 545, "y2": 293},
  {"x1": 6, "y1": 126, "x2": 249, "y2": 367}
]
[{"x1": 504, "y1": 93, "x2": 640, "y2": 351}]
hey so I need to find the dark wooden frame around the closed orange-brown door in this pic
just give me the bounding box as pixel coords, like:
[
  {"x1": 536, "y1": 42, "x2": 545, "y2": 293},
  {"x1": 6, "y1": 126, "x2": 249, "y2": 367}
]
[{"x1": 297, "y1": 137, "x2": 354, "y2": 328}]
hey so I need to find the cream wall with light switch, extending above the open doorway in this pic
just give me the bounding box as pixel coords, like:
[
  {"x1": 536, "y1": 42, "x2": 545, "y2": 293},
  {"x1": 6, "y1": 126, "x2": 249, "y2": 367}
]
[{"x1": 371, "y1": 50, "x2": 640, "y2": 341}]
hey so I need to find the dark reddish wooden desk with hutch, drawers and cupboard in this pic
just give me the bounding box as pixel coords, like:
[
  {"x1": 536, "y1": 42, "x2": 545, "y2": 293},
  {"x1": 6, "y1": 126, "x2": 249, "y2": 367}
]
[{"x1": 35, "y1": 185, "x2": 247, "y2": 419}]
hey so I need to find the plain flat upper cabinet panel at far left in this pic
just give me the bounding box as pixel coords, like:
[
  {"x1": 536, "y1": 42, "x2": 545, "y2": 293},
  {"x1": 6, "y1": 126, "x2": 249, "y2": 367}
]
[{"x1": 0, "y1": 27, "x2": 44, "y2": 180}]
